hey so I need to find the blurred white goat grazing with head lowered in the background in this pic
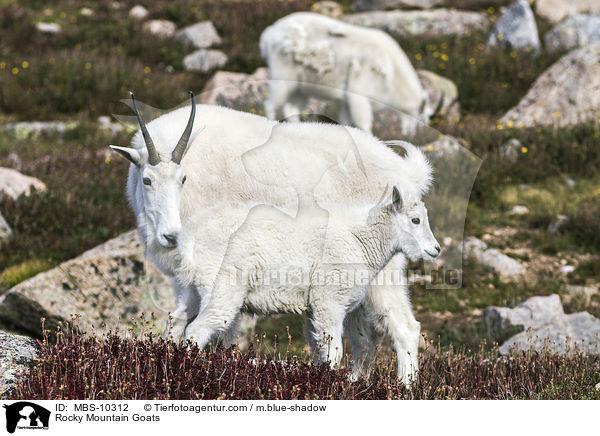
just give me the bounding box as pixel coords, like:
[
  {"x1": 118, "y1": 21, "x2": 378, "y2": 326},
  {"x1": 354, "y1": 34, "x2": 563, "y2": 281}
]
[{"x1": 260, "y1": 12, "x2": 431, "y2": 132}]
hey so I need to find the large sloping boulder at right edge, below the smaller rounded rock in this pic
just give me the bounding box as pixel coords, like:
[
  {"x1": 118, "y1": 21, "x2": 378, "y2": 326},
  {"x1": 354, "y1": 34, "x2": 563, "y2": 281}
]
[{"x1": 500, "y1": 43, "x2": 600, "y2": 127}]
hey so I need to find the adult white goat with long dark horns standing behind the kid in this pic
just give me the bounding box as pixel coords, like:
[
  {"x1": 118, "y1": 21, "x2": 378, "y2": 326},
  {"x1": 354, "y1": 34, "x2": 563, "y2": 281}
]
[{"x1": 111, "y1": 93, "x2": 439, "y2": 383}]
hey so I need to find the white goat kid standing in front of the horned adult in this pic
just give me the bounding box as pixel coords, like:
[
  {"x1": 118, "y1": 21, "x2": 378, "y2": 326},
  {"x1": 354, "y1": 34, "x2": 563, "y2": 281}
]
[{"x1": 177, "y1": 187, "x2": 438, "y2": 365}]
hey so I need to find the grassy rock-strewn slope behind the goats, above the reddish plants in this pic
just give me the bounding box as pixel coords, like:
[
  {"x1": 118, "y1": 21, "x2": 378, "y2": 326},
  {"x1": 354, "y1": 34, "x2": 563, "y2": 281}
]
[{"x1": 0, "y1": 0, "x2": 600, "y2": 391}]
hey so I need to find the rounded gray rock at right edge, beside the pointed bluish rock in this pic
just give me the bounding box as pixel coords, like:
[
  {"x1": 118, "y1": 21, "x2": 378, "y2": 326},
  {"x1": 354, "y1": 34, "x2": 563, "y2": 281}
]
[{"x1": 544, "y1": 15, "x2": 600, "y2": 52}]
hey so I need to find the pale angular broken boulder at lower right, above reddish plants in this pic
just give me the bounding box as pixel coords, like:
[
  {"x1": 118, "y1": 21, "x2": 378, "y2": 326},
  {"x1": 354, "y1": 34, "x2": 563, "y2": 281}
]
[{"x1": 482, "y1": 295, "x2": 600, "y2": 354}]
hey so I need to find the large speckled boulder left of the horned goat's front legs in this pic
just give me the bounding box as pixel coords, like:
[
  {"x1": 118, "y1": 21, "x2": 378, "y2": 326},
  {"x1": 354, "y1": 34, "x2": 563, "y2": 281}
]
[{"x1": 0, "y1": 231, "x2": 173, "y2": 335}]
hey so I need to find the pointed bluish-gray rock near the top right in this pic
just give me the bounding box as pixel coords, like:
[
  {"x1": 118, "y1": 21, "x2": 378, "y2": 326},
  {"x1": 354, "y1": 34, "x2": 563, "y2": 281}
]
[{"x1": 487, "y1": 0, "x2": 540, "y2": 53}]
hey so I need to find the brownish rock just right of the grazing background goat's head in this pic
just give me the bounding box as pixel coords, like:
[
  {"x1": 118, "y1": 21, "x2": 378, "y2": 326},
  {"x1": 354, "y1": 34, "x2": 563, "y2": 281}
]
[{"x1": 417, "y1": 70, "x2": 460, "y2": 122}]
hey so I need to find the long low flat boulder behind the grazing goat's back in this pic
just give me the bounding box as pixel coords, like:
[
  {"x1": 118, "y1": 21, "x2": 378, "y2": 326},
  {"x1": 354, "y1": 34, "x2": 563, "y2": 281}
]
[{"x1": 342, "y1": 9, "x2": 490, "y2": 38}]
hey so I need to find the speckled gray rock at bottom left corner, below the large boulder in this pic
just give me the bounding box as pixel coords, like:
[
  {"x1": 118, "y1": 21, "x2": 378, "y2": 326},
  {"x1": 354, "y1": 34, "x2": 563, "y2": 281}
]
[{"x1": 0, "y1": 330, "x2": 38, "y2": 398}]
